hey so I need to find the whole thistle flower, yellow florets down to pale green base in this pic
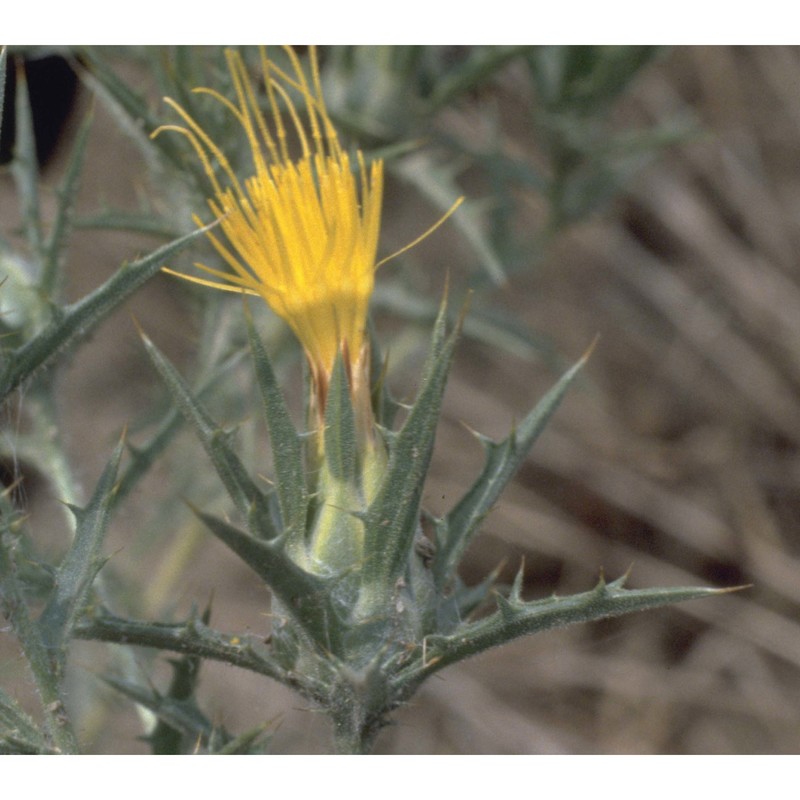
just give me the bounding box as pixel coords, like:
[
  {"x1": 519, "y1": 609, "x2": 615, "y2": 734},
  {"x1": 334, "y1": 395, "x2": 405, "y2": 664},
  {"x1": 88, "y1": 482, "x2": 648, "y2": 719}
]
[{"x1": 153, "y1": 47, "x2": 461, "y2": 573}]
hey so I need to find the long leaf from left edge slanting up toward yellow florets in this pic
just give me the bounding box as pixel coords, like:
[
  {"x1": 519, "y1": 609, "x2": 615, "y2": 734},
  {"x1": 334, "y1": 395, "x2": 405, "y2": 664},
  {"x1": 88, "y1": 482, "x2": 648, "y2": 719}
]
[{"x1": 0, "y1": 223, "x2": 208, "y2": 402}]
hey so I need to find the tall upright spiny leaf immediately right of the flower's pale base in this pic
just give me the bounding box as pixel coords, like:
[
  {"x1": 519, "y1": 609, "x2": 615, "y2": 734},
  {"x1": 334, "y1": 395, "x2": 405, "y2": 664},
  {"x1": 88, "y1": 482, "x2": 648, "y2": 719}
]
[{"x1": 362, "y1": 296, "x2": 459, "y2": 611}]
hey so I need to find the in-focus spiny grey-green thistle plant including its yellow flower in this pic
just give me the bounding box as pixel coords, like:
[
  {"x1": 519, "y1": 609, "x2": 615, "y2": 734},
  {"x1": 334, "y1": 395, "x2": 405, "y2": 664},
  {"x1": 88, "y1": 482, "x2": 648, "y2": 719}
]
[{"x1": 0, "y1": 48, "x2": 718, "y2": 753}]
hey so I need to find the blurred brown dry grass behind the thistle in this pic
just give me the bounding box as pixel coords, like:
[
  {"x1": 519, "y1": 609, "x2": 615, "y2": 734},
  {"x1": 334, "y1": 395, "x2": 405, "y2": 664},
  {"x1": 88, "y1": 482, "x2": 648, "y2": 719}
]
[{"x1": 2, "y1": 48, "x2": 800, "y2": 753}]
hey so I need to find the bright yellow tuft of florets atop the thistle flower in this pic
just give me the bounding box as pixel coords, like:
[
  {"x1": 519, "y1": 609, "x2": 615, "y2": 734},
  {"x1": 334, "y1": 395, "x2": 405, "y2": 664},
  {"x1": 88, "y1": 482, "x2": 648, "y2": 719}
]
[{"x1": 153, "y1": 47, "x2": 383, "y2": 403}]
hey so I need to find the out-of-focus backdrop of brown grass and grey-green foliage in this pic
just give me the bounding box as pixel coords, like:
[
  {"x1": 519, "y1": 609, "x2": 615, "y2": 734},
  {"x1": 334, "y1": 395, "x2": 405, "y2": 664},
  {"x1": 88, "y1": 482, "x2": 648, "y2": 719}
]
[{"x1": 0, "y1": 47, "x2": 800, "y2": 754}]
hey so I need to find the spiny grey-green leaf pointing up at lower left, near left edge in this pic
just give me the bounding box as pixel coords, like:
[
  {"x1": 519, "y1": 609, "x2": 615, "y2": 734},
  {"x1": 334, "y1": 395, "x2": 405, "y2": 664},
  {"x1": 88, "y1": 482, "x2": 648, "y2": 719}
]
[{"x1": 39, "y1": 440, "x2": 124, "y2": 649}]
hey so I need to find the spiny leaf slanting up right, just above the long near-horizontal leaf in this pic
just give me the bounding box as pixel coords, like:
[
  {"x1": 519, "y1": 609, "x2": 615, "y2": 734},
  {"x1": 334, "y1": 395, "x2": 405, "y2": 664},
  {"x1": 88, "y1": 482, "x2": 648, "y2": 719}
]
[{"x1": 433, "y1": 344, "x2": 589, "y2": 591}]
